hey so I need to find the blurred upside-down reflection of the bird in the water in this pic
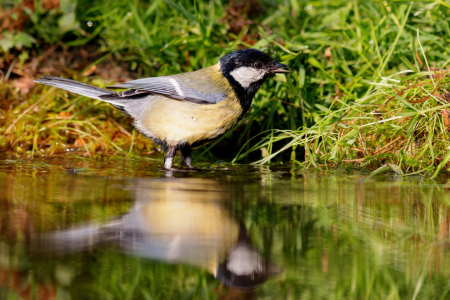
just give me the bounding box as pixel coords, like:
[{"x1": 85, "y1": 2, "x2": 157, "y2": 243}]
[{"x1": 36, "y1": 178, "x2": 279, "y2": 299}]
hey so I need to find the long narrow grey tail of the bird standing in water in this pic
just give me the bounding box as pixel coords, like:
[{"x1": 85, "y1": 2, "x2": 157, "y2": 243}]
[{"x1": 34, "y1": 76, "x2": 116, "y2": 104}]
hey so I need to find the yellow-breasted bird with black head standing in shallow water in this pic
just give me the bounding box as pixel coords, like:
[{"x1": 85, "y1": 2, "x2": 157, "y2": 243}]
[{"x1": 34, "y1": 48, "x2": 290, "y2": 170}]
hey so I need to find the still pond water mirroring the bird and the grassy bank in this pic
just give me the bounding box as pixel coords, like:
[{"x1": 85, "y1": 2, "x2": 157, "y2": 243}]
[{"x1": 0, "y1": 157, "x2": 450, "y2": 299}]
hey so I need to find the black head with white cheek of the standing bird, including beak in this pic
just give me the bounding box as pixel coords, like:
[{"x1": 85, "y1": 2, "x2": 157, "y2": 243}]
[{"x1": 220, "y1": 49, "x2": 289, "y2": 114}]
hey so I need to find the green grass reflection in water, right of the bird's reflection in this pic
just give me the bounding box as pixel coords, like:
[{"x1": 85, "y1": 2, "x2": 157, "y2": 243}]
[{"x1": 244, "y1": 174, "x2": 450, "y2": 299}]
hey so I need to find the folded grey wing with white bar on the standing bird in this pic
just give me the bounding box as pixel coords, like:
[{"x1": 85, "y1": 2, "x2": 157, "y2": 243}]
[{"x1": 105, "y1": 76, "x2": 226, "y2": 104}]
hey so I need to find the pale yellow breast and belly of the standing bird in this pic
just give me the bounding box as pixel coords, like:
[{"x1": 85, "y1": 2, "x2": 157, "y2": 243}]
[{"x1": 141, "y1": 65, "x2": 242, "y2": 146}]
